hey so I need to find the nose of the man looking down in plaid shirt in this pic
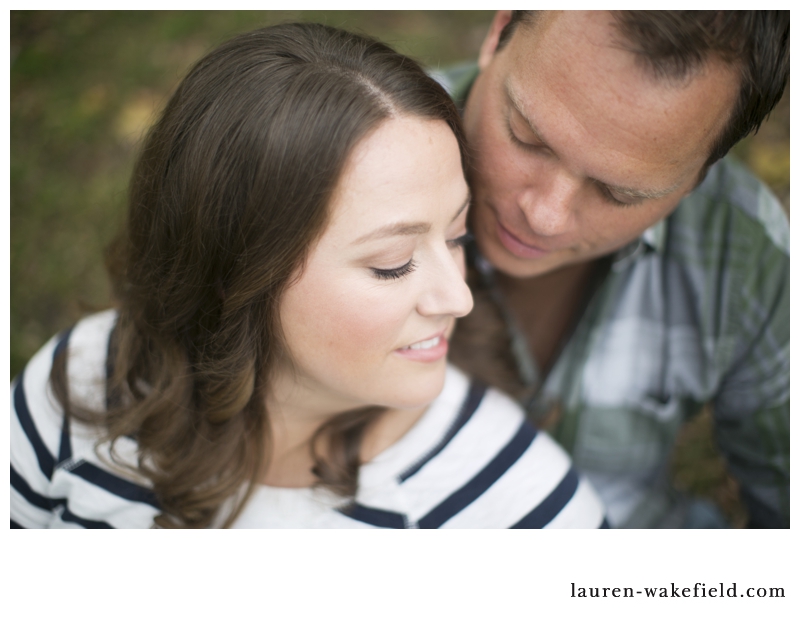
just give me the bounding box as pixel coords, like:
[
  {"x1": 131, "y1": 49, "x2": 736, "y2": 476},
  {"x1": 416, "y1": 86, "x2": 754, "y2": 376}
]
[{"x1": 517, "y1": 170, "x2": 580, "y2": 237}]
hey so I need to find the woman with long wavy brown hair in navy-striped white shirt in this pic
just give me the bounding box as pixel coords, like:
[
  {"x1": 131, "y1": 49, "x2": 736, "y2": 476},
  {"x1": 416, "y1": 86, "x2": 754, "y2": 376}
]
[{"x1": 11, "y1": 24, "x2": 603, "y2": 528}]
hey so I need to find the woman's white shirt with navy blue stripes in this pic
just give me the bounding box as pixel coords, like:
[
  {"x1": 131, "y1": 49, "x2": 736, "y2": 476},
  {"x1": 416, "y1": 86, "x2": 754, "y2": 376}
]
[{"x1": 11, "y1": 311, "x2": 606, "y2": 528}]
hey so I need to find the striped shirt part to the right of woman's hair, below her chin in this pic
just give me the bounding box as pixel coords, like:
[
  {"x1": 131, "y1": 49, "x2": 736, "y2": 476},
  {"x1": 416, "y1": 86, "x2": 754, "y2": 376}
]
[{"x1": 236, "y1": 368, "x2": 608, "y2": 528}]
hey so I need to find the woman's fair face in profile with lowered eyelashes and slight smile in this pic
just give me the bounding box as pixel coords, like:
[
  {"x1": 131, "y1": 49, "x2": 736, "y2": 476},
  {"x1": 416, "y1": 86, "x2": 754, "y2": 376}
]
[{"x1": 276, "y1": 116, "x2": 472, "y2": 412}]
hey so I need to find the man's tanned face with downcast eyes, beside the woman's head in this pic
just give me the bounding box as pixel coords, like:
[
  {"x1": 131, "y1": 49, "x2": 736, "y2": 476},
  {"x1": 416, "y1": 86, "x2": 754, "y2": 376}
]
[{"x1": 464, "y1": 11, "x2": 739, "y2": 277}]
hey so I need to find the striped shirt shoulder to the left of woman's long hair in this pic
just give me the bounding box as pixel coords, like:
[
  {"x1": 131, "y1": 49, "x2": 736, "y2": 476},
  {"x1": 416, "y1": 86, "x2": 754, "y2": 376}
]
[{"x1": 10, "y1": 311, "x2": 157, "y2": 528}]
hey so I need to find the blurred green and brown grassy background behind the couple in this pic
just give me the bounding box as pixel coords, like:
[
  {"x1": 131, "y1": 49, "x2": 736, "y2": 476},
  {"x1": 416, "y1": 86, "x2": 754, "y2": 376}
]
[{"x1": 10, "y1": 11, "x2": 789, "y2": 525}]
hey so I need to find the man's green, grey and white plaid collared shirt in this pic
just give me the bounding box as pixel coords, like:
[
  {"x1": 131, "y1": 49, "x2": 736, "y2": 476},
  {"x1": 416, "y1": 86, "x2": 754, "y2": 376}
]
[{"x1": 434, "y1": 64, "x2": 789, "y2": 527}]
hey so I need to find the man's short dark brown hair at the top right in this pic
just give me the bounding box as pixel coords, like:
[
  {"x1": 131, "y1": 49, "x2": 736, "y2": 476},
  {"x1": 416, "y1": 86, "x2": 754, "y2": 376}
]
[{"x1": 497, "y1": 11, "x2": 789, "y2": 177}]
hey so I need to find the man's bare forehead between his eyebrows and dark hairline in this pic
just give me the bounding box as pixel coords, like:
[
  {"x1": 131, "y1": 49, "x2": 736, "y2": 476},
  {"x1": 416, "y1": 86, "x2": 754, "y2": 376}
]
[{"x1": 494, "y1": 13, "x2": 738, "y2": 190}]
